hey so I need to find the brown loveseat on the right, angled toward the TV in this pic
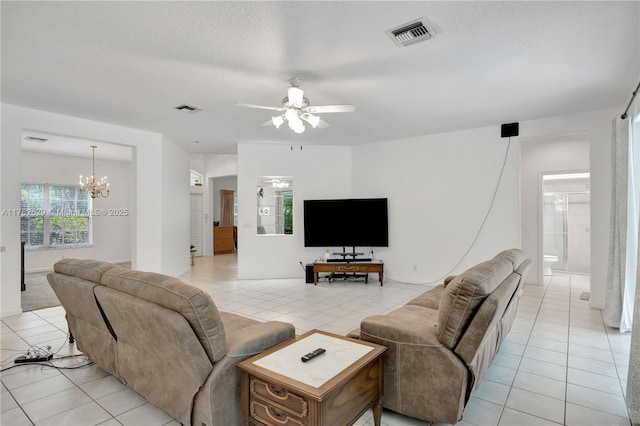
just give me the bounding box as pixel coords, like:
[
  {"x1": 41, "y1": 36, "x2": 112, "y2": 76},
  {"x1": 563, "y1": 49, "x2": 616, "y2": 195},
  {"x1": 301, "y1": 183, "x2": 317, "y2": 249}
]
[{"x1": 351, "y1": 249, "x2": 532, "y2": 423}]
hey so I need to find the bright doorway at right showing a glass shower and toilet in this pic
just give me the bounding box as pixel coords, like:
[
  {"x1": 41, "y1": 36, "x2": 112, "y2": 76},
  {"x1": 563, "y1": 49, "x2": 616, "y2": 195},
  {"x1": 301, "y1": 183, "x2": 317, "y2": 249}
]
[{"x1": 541, "y1": 172, "x2": 591, "y2": 279}]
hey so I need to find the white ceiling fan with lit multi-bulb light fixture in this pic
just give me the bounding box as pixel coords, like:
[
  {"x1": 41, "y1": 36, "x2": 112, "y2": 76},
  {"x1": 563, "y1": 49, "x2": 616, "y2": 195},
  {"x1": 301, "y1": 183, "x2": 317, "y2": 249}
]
[{"x1": 236, "y1": 77, "x2": 356, "y2": 133}]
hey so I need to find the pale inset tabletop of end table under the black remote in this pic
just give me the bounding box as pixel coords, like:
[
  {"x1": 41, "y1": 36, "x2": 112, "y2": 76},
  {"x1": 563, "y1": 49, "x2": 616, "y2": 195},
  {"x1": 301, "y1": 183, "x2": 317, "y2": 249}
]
[{"x1": 254, "y1": 333, "x2": 373, "y2": 388}]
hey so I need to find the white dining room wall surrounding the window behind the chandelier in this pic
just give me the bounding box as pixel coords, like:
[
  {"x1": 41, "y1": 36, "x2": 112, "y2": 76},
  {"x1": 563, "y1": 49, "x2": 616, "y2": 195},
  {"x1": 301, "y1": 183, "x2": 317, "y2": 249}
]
[{"x1": 22, "y1": 152, "x2": 131, "y2": 272}]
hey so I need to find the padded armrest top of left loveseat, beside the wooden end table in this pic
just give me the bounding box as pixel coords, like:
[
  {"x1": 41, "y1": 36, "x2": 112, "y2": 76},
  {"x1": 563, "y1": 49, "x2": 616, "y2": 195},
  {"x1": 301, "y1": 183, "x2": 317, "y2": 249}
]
[{"x1": 227, "y1": 321, "x2": 296, "y2": 358}]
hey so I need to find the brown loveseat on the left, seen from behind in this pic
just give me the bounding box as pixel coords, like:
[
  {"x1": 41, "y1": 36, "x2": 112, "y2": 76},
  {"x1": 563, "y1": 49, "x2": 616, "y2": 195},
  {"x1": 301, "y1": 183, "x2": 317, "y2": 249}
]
[{"x1": 47, "y1": 259, "x2": 295, "y2": 426}]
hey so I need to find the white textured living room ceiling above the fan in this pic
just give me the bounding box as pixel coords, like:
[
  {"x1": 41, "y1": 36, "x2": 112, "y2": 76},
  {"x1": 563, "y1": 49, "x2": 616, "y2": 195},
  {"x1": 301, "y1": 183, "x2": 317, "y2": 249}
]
[{"x1": 1, "y1": 1, "x2": 640, "y2": 153}]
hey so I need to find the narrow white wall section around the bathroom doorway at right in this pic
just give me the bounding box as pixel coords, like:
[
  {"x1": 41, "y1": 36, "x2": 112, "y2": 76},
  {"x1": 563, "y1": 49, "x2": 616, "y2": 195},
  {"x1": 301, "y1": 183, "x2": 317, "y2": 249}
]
[{"x1": 520, "y1": 133, "x2": 589, "y2": 284}]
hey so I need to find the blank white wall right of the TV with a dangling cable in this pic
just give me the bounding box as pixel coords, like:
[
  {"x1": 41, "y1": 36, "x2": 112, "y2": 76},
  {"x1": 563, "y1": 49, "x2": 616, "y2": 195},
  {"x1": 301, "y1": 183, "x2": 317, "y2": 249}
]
[{"x1": 353, "y1": 126, "x2": 520, "y2": 283}]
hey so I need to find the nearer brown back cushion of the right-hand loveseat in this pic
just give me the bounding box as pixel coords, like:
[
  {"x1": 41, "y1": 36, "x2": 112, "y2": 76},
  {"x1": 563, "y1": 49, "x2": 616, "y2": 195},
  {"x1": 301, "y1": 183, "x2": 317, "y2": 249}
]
[{"x1": 438, "y1": 256, "x2": 513, "y2": 349}]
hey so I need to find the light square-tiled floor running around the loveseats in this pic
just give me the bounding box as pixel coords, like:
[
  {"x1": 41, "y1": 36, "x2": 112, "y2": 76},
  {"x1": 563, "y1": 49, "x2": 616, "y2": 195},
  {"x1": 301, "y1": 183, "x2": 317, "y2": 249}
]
[{"x1": 0, "y1": 255, "x2": 630, "y2": 426}]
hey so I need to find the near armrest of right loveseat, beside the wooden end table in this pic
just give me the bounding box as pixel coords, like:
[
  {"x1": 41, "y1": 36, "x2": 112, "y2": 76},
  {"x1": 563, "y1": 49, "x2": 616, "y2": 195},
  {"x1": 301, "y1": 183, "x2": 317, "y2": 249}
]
[{"x1": 360, "y1": 305, "x2": 468, "y2": 423}]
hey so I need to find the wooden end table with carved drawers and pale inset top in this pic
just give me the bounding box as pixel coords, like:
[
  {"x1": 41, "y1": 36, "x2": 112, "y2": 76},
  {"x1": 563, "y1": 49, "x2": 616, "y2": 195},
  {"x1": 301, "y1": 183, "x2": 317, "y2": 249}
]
[{"x1": 238, "y1": 330, "x2": 387, "y2": 426}]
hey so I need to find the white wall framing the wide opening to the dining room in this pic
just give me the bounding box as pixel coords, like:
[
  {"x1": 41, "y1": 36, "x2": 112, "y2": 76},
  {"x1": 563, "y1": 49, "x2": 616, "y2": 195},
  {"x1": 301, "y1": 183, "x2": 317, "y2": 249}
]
[{"x1": 0, "y1": 104, "x2": 189, "y2": 316}]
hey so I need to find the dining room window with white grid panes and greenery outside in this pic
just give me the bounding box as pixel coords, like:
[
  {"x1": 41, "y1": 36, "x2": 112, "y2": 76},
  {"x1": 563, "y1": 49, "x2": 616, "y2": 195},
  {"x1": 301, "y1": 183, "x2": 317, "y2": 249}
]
[{"x1": 20, "y1": 185, "x2": 91, "y2": 249}]
